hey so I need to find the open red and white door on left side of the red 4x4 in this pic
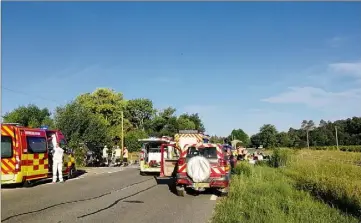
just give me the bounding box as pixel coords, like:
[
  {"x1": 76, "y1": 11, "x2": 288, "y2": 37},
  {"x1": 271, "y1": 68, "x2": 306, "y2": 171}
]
[{"x1": 160, "y1": 144, "x2": 181, "y2": 177}]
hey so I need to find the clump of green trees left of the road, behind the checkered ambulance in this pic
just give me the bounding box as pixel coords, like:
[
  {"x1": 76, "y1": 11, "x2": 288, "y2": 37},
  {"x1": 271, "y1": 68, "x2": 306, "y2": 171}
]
[{"x1": 3, "y1": 88, "x2": 205, "y2": 152}]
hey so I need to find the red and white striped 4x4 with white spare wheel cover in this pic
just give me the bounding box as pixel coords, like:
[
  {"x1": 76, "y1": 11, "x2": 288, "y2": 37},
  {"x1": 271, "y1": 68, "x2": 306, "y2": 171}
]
[{"x1": 161, "y1": 143, "x2": 231, "y2": 196}]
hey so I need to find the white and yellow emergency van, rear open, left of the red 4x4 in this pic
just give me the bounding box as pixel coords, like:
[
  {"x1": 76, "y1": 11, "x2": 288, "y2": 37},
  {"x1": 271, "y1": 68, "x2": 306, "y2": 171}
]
[{"x1": 138, "y1": 136, "x2": 176, "y2": 175}]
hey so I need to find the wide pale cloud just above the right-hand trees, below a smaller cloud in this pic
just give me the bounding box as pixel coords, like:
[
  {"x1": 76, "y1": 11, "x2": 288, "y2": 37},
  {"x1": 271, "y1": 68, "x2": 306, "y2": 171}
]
[{"x1": 261, "y1": 86, "x2": 361, "y2": 108}]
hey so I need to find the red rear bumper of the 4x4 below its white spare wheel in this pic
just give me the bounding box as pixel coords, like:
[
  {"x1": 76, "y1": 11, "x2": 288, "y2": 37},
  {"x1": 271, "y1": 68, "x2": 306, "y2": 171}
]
[{"x1": 176, "y1": 174, "x2": 230, "y2": 188}]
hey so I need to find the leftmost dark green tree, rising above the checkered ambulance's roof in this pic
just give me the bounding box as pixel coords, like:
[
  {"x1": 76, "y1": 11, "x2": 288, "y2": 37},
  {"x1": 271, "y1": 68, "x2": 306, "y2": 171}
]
[{"x1": 3, "y1": 104, "x2": 54, "y2": 128}]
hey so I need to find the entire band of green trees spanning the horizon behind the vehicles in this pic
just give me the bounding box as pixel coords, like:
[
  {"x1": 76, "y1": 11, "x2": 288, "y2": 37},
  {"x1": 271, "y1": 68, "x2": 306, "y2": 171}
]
[{"x1": 3, "y1": 88, "x2": 361, "y2": 151}]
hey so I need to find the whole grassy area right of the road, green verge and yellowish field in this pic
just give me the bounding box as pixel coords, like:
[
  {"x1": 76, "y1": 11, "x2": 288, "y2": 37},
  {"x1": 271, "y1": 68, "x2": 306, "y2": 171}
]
[{"x1": 212, "y1": 149, "x2": 361, "y2": 223}]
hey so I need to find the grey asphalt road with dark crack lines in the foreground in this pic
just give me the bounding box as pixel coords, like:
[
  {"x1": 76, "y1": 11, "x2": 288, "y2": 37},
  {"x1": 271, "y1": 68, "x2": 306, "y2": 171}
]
[{"x1": 1, "y1": 168, "x2": 217, "y2": 223}]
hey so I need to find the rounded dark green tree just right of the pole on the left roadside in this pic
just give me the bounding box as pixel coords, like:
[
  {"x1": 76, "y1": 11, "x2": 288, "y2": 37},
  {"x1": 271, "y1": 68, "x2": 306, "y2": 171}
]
[{"x1": 126, "y1": 98, "x2": 155, "y2": 131}]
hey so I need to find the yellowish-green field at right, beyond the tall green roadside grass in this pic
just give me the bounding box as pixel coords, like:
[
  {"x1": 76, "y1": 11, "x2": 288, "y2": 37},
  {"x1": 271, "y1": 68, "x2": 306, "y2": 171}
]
[{"x1": 283, "y1": 150, "x2": 361, "y2": 218}]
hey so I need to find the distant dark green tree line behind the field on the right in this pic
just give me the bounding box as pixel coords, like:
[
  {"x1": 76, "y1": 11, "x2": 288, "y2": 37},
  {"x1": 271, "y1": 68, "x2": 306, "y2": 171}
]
[{"x1": 211, "y1": 117, "x2": 361, "y2": 151}]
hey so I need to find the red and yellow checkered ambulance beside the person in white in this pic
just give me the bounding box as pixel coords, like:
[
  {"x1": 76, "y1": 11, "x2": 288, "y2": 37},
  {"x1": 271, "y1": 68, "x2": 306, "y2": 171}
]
[{"x1": 1, "y1": 123, "x2": 75, "y2": 186}]
